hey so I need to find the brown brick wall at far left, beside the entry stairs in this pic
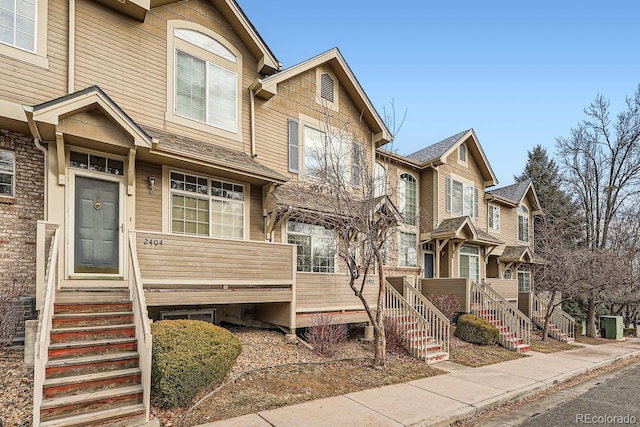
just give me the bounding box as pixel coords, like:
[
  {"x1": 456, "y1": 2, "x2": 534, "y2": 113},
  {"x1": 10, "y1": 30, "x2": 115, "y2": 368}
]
[{"x1": 0, "y1": 129, "x2": 44, "y2": 295}]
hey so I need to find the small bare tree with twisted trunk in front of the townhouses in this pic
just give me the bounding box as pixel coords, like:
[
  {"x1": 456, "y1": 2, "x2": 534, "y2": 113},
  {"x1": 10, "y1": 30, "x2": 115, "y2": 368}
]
[{"x1": 278, "y1": 106, "x2": 404, "y2": 367}]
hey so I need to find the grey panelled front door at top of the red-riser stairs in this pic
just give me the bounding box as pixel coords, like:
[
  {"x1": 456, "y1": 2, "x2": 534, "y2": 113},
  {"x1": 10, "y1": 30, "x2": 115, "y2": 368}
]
[{"x1": 73, "y1": 176, "x2": 120, "y2": 274}]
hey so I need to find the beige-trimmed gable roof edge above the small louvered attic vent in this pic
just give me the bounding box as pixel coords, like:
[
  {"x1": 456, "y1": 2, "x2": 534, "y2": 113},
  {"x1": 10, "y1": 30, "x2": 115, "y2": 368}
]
[{"x1": 251, "y1": 48, "x2": 393, "y2": 147}]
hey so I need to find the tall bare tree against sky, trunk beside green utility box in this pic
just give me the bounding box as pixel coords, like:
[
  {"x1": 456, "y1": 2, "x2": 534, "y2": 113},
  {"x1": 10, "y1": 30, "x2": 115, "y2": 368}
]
[{"x1": 556, "y1": 83, "x2": 640, "y2": 337}]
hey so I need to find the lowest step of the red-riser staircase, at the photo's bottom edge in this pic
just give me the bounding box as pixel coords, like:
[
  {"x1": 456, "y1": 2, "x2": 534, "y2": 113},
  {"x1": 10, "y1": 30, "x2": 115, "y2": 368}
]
[{"x1": 40, "y1": 404, "x2": 145, "y2": 427}]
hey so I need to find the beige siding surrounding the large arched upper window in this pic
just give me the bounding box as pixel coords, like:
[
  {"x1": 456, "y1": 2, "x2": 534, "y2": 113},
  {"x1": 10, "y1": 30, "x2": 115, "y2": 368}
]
[{"x1": 71, "y1": 1, "x2": 259, "y2": 152}]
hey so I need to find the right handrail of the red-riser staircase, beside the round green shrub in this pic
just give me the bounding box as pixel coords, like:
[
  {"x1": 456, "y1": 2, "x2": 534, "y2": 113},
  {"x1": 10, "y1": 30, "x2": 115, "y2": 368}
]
[{"x1": 129, "y1": 231, "x2": 153, "y2": 421}]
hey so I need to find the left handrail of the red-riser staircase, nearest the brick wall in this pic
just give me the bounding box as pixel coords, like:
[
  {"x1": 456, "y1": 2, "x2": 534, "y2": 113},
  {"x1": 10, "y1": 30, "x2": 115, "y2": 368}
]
[{"x1": 33, "y1": 227, "x2": 60, "y2": 426}]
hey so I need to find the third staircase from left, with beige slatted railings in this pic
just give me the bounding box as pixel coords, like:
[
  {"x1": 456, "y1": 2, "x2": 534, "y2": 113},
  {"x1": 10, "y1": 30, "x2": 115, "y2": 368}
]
[{"x1": 470, "y1": 280, "x2": 531, "y2": 351}]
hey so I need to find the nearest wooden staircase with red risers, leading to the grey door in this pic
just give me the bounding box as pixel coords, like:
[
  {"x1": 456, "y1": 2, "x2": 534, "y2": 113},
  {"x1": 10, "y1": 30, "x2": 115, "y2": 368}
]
[{"x1": 39, "y1": 288, "x2": 145, "y2": 427}]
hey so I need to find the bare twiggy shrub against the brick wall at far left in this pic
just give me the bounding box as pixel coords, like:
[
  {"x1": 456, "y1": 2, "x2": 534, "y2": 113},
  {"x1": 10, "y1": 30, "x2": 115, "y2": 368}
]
[{"x1": 0, "y1": 280, "x2": 27, "y2": 350}]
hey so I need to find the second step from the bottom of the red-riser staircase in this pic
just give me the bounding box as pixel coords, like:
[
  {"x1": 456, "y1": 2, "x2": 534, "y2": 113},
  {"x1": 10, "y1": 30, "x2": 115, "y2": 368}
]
[{"x1": 40, "y1": 385, "x2": 143, "y2": 421}]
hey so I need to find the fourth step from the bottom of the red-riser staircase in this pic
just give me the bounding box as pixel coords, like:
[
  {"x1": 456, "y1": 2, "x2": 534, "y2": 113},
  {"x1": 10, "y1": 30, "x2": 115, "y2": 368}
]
[{"x1": 45, "y1": 352, "x2": 139, "y2": 379}]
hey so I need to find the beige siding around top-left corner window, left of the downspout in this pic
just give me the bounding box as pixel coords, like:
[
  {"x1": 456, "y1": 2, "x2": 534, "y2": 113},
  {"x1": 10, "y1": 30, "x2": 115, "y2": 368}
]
[{"x1": 0, "y1": 0, "x2": 68, "y2": 107}]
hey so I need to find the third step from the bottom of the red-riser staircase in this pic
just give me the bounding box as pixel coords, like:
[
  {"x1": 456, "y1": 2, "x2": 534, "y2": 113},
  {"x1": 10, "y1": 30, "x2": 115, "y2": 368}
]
[{"x1": 44, "y1": 368, "x2": 141, "y2": 399}]
